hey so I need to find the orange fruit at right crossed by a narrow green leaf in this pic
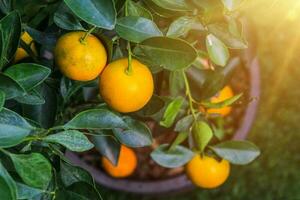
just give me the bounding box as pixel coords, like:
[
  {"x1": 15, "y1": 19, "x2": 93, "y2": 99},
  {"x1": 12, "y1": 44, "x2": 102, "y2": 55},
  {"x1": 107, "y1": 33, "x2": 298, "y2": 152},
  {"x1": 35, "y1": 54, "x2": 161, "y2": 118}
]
[{"x1": 207, "y1": 86, "x2": 234, "y2": 117}]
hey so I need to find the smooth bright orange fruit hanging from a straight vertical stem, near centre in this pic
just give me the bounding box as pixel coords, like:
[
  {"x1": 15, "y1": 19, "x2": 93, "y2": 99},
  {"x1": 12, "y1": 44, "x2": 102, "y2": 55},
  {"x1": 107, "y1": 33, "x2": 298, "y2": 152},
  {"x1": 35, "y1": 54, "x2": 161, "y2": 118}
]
[{"x1": 99, "y1": 58, "x2": 154, "y2": 113}]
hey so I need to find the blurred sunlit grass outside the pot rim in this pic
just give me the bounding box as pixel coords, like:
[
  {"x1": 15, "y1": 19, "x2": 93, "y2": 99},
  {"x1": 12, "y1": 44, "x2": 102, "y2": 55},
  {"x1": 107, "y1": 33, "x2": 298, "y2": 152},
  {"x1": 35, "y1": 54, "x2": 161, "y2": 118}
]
[{"x1": 102, "y1": 0, "x2": 300, "y2": 200}]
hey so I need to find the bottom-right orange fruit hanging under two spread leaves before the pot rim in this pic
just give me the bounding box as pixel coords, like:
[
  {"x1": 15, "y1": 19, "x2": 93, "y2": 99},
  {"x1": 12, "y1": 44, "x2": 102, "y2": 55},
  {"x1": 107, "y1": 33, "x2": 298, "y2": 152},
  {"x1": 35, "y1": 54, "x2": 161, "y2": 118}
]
[{"x1": 185, "y1": 155, "x2": 230, "y2": 189}]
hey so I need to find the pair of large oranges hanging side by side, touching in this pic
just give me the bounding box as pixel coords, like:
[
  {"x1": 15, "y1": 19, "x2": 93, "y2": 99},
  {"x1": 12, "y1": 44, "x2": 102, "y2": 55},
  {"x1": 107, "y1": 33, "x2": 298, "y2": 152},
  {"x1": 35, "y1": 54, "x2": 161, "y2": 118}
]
[{"x1": 54, "y1": 31, "x2": 154, "y2": 113}]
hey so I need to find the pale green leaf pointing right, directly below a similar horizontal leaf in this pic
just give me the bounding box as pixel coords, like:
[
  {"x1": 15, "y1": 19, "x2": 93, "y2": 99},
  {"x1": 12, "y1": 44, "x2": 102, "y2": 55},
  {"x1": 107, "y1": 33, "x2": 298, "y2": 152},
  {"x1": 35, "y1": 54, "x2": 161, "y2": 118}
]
[{"x1": 43, "y1": 130, "x2": 94, "y2": 152}]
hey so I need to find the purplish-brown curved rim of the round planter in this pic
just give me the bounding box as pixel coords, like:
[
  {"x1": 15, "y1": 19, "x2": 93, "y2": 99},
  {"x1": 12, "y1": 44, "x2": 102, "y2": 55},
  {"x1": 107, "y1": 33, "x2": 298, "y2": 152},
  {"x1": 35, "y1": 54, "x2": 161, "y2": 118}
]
[{"x1": 66, "y1": 44, "x2": 260, "y2": 195}]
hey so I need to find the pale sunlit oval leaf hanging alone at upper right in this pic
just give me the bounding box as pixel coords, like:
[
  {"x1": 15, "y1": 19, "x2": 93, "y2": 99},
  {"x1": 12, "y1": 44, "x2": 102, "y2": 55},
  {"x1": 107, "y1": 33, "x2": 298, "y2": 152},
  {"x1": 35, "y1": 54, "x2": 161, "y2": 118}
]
[{"x1": 206, "y1": 34, "x2": 229, "y2": 67}]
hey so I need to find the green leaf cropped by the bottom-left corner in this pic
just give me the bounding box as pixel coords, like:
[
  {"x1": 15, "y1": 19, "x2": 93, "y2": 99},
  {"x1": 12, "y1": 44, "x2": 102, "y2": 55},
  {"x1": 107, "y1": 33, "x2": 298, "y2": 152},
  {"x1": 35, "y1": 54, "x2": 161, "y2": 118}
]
[{"x1": 0, "y1": 162, "x2": 17, "y2": 200}]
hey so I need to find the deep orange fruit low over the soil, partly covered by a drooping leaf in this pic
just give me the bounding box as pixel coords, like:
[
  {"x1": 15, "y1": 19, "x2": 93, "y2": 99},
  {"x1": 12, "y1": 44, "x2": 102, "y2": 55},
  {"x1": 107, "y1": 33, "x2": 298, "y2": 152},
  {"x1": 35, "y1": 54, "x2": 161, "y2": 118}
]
[{"x1": 102, "y1": 145, "x2": 137, "y2": 178}]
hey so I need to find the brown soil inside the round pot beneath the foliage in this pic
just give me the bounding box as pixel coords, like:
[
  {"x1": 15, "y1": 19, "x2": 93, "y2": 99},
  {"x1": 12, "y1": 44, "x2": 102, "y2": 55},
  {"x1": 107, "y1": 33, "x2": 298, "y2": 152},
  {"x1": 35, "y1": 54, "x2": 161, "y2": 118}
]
[{"x1": 81, "y1": 62, "x2": 251, "y2": 180}]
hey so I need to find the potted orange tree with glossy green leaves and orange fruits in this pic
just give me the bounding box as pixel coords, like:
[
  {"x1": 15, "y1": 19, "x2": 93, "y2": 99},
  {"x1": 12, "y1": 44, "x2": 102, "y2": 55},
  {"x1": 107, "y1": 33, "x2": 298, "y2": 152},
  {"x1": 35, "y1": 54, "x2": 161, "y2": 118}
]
[{"x1": 0, "y1": 0, "x2": 260, "y2": 200}]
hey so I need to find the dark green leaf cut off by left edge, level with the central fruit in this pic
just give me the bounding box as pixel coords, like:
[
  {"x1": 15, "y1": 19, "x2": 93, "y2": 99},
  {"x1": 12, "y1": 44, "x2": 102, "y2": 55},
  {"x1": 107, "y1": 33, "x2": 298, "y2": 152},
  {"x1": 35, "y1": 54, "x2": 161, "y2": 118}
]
[{"x1": 0, "y1": 74, "x2": 25, "y2": 99}]
